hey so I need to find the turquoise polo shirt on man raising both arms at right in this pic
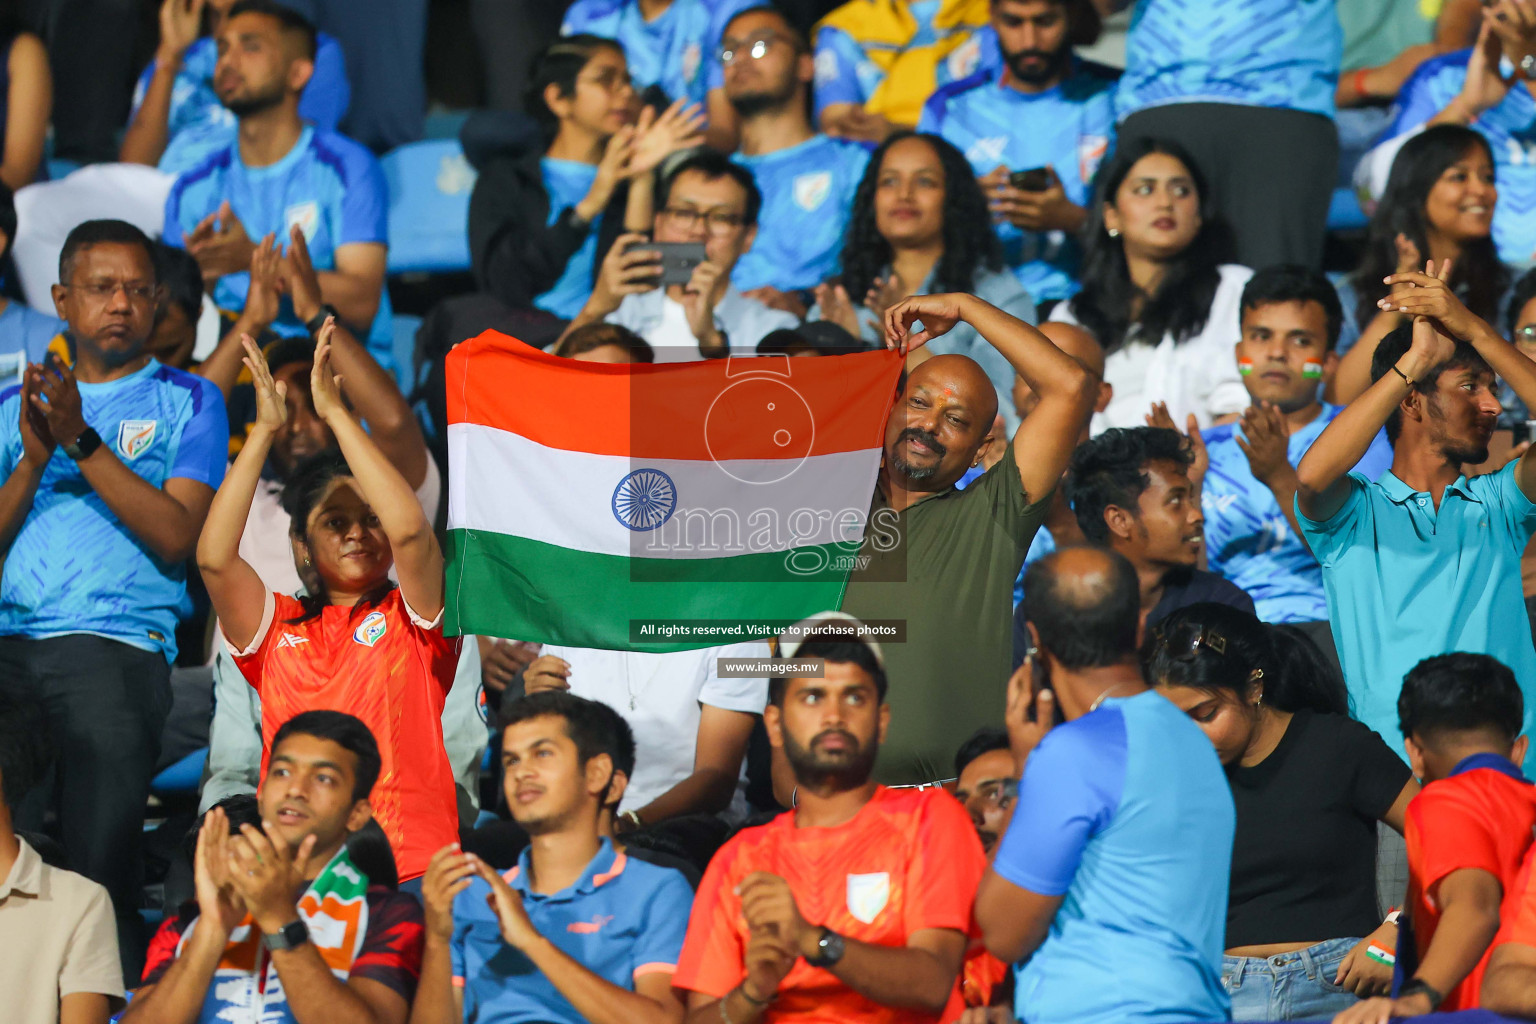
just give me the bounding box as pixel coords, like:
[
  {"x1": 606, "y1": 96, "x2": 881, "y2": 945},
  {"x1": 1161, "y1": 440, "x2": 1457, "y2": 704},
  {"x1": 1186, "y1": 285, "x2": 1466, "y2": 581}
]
[{"x1": 1296, "y1": 462, "x2": 1536, "y2": 772}]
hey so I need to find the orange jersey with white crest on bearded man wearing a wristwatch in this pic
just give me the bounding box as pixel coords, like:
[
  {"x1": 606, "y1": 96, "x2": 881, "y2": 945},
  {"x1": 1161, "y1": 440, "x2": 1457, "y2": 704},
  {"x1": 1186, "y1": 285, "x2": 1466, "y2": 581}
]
[{"x1": 673, "y1": 786, "x2": 986, "y2": 1024}]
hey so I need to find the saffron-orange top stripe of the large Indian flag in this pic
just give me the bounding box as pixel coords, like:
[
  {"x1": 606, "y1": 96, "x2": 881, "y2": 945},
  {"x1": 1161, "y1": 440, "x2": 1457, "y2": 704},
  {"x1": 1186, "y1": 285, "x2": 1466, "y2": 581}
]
[{"x1": 447, "y1": 332, "x2": 902, "y2": 461}]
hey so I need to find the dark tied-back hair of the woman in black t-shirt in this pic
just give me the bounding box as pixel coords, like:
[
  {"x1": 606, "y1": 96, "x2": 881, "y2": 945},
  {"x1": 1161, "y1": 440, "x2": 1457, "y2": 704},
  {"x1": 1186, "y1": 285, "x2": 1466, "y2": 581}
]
[{"x1": 1142, "y1": 604, "x2": 1349, "y2": 715}]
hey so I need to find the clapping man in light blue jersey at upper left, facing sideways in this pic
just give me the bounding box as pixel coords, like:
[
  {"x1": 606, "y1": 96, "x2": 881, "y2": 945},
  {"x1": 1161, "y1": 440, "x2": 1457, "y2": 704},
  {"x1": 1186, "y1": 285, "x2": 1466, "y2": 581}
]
[{"x1": 164, "y1": 0, "x2": 395, "y2": 368}]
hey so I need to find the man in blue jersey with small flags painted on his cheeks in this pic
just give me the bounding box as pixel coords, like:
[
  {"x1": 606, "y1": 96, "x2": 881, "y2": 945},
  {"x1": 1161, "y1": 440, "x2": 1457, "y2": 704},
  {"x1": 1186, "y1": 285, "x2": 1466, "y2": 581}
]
[{"x1": 1201, "y1": 264, "x2": 1392, "y2": 651}]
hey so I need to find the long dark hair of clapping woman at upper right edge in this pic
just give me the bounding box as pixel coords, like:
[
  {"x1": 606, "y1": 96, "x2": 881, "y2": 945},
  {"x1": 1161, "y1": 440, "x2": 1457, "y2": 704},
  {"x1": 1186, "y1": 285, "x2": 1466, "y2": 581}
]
[{"x1": 1350, "y1": 124, "x2": 1510, "y2": 327}]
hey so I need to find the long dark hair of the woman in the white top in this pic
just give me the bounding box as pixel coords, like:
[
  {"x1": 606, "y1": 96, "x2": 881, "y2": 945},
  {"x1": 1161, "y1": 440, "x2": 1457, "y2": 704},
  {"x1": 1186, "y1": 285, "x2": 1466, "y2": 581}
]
[{"x1": 1071, "y1": 138, "x2": 1227, "y2": 353}]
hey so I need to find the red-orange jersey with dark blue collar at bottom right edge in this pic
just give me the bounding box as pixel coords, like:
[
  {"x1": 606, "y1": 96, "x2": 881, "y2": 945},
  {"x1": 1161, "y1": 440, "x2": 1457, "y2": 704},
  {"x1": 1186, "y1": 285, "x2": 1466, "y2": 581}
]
[{"x1": 1398, "y1": 754, "x2": 1536, "y2": 1013}]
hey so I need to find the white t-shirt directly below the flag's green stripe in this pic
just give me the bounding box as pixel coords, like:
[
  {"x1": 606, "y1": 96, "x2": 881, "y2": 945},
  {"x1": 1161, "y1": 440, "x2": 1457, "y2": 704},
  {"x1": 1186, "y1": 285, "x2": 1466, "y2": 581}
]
[{"x1": 541, "y1": 642, "x2": 773, "y2": 820}]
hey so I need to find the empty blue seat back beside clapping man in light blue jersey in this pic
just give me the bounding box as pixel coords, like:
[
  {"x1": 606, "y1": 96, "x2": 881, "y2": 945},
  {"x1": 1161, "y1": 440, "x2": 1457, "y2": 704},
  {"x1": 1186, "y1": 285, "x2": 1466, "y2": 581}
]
[{"x1": 381, "y1": 140, "x2": 476, "y2": 273}]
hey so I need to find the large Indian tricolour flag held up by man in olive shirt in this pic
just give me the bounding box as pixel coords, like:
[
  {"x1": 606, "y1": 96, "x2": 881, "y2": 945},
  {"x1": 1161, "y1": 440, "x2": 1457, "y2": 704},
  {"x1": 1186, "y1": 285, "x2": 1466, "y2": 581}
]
[{"x1": 445, "y1": 332, "x2": 902, "y2": 651}]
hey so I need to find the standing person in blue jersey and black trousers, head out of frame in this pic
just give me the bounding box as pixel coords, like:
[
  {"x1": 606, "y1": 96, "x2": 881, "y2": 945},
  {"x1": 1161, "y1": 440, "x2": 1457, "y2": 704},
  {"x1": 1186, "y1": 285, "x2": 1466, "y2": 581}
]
[{"x1": 1114, "y1": 0, "x2": 1344, "y2": 267}]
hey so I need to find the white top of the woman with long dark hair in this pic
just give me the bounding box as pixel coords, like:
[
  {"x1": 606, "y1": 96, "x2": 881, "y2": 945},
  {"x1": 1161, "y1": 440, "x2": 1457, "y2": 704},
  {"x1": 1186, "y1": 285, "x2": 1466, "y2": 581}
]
[{"x1": 1051, "y1": 264, "x2": 1253, "y2": 434}]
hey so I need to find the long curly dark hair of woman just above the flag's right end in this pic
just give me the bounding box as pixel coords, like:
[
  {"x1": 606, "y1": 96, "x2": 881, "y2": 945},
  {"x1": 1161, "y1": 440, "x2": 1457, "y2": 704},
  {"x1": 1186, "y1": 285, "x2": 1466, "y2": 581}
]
[{"x1": 843, "y1": 132, "x2": 1003, "y2": 302}]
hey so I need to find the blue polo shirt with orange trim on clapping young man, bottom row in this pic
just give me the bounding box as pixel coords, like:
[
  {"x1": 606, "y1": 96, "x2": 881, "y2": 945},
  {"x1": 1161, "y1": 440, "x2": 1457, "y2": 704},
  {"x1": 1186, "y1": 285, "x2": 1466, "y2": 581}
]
[{"x1": 452, "y1": 838, "x2": 693, "y2": 1024}]
